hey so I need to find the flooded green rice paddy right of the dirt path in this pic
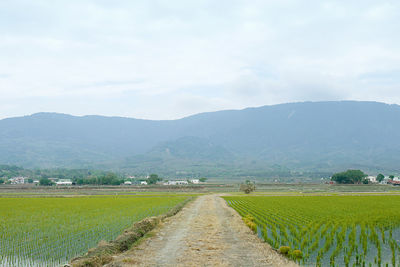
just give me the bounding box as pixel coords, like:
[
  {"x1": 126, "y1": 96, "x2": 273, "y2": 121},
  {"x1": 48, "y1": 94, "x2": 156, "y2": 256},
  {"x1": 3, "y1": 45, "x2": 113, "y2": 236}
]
[{"x1": 224, "y1": 195, "x2": 400, "y2": 266}]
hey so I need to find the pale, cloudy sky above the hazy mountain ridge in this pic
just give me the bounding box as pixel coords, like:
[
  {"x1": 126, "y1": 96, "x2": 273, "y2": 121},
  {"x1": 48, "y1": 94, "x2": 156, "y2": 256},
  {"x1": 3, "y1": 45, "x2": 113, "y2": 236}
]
[{"x1": 0, "y1": 0, "x2": 400, "y2": 119}]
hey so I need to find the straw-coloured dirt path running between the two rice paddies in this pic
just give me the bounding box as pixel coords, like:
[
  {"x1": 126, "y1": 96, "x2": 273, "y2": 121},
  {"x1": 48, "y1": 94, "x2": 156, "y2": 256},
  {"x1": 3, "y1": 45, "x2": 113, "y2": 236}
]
[{"x1": 107, "y1": 195, "x2": 296, "y2": 267}]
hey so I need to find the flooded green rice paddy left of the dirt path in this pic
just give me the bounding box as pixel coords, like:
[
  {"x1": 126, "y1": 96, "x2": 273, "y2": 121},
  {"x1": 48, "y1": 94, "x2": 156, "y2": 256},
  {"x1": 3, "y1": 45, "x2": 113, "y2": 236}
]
[{"x1": 0, "y1": 195, "x2": 188, "y2": 266}]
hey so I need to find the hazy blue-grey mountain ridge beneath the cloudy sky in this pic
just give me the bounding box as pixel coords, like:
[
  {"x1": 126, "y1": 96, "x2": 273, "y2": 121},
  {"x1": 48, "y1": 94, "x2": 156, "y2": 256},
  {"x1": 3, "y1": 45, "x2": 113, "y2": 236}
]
[{"x1": 0, "y1": 101, "x2": 400, "y2": 175}]
